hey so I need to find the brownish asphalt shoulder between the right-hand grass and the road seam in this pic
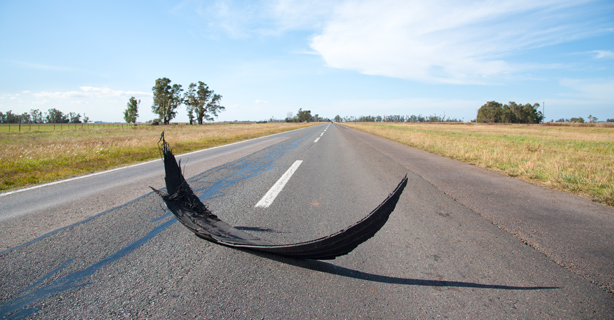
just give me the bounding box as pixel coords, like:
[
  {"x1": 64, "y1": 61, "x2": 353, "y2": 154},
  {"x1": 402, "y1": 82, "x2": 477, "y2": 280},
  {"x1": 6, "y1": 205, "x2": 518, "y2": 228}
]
[{"x1": 344, "y1": 127, "x2": 614, "y2": 294}]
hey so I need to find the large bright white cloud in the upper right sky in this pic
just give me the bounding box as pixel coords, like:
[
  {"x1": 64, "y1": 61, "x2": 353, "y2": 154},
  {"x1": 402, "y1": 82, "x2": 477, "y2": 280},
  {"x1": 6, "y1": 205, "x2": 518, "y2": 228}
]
[{"x1": 311, "y1": 0, "x2": 608, "y2": 84}]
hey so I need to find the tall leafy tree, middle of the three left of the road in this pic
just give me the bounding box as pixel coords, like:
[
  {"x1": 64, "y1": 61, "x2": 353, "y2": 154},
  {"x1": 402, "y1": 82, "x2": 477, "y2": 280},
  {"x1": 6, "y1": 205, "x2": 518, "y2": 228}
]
[{"x1": 151, "y1": 78, "x2": 183, "y2": 124}]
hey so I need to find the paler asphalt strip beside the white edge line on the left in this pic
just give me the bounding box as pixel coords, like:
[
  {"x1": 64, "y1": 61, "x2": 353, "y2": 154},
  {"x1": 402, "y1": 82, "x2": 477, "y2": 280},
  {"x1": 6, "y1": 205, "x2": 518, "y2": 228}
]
[{"x1": 0, "y1": 134, "x2": 287, "y2": 251}]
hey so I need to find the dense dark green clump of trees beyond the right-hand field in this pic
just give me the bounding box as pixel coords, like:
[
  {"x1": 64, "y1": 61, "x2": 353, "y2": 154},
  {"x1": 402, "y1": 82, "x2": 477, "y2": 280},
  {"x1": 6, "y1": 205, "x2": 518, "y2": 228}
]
[{"x1": 476, "y1": 101, "x2": 544, "y2": 123}]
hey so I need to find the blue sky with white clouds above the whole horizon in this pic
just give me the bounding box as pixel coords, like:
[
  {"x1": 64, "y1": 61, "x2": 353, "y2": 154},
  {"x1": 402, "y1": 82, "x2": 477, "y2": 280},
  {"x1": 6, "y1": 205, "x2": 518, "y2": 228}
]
[{"x1": 0, "y1": 0, "x2": 614, "y2": 122}]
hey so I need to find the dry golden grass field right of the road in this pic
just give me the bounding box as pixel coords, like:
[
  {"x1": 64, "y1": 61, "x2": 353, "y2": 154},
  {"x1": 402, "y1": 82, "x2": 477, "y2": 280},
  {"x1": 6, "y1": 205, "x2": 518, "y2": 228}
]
[{"x1": 344, "y1": 123, "x2": 614, "y2": 206}]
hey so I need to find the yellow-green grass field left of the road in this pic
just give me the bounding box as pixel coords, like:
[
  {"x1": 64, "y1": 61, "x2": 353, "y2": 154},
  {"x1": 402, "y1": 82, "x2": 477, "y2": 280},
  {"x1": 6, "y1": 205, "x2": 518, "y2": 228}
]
[{"x1": 0, "y1": 123, "x2": 313, "y2": 191}]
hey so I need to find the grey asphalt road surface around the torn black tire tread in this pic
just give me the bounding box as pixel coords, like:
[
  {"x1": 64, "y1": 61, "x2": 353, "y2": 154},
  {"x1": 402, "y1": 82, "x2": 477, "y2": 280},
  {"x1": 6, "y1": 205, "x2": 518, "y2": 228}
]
[{"x1": 0, "y1": 124, "x2": 614, "y2": 319}]
